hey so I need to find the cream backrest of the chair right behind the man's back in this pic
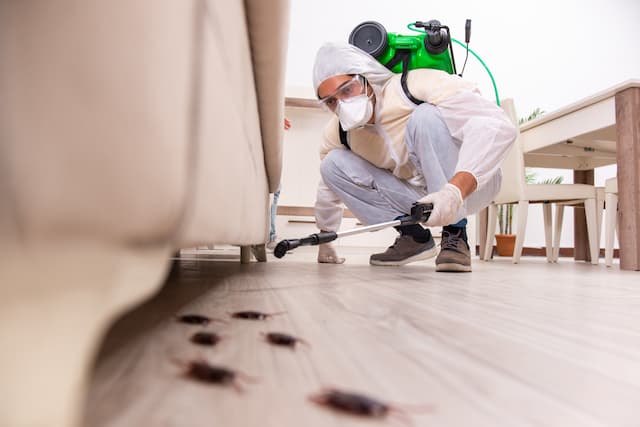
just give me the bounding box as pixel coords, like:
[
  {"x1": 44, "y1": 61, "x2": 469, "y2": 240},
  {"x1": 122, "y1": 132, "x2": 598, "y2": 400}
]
[{"x1": 493, "y1": 98, "x2": 526, "y2": 204}]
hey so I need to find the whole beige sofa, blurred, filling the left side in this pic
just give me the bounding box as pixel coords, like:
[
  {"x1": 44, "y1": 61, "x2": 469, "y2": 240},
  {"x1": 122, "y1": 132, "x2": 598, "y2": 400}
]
[{"x1": 0, "y1": 0, "x2": 288, "y2": 426}]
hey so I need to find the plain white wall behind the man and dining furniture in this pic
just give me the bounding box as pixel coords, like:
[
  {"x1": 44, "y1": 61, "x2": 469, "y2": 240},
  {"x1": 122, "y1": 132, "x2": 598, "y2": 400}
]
[{"x1": 281, "y1": 0, "x2": 640, "y2": 246}]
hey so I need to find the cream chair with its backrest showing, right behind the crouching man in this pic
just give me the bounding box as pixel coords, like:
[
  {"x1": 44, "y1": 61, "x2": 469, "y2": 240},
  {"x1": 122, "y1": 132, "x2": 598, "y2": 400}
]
[{"x1": 484, "y1": 99, "x2": 599, "y2": 264}]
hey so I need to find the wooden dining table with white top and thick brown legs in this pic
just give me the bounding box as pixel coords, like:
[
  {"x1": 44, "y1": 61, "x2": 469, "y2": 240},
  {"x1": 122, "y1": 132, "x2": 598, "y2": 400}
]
[{"x1": 520, "y1": 79, "x2": 640, "y2": 270}]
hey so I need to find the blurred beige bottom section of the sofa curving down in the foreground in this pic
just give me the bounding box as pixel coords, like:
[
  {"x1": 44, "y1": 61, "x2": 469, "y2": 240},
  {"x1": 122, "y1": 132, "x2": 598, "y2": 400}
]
[{"x1": 0, "y1": 242, "x2": 172, "y2": 426}]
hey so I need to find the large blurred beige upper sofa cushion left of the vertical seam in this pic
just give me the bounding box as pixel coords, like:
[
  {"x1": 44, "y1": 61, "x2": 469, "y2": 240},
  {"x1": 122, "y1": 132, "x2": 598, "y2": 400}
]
[{"x1": 0, "y1": 0, "x2": 194, "y2": 242}]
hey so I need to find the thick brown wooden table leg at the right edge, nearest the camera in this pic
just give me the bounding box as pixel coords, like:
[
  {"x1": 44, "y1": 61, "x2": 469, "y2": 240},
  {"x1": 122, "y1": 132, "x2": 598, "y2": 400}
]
[{"x1": 616, "y1": 87, "x2": 640, "y2": 270}]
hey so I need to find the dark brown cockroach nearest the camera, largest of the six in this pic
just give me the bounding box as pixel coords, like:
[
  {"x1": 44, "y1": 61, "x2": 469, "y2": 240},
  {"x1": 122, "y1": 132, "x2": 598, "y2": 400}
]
[{"x1": 309, "y1": 388, "x2": 432, "y2": 425}]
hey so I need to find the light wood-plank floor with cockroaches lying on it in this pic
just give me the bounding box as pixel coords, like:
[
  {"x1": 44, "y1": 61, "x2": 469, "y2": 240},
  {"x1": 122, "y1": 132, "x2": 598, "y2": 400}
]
[{"x1": 85, "y1": 248, "x2": 640, "y2": 427}]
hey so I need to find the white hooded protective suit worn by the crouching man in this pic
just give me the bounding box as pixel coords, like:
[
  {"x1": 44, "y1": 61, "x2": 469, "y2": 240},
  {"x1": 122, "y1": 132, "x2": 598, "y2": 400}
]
[{"x1": 313, "y1": 43, "x2": 516, "y2": 231}]
